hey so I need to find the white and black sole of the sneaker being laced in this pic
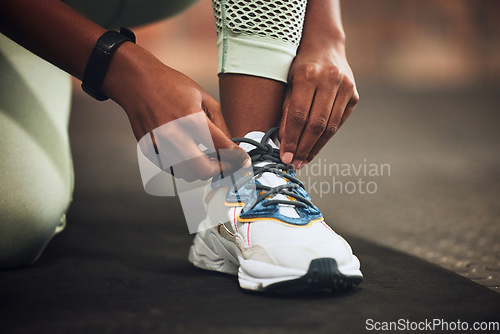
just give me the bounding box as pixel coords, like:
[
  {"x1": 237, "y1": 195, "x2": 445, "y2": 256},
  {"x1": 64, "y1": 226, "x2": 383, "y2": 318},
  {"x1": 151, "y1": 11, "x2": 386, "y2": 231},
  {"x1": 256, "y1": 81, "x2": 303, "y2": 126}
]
[{"x1": 189, "y1": 228, "x2": 363, "y2": 294}]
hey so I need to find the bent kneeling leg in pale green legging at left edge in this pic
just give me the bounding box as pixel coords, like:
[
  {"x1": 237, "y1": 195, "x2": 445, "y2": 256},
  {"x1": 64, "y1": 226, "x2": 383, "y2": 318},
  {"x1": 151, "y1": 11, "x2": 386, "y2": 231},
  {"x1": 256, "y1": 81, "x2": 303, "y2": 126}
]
[{"x1": 0, "y1": 35, "x2": 73, "y2": 269}]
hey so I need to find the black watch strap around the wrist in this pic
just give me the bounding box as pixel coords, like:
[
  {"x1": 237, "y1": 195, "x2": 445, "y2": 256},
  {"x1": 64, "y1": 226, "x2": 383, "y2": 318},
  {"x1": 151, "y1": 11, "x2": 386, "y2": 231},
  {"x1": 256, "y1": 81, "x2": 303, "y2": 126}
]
[{"x1": 82, "y1": 28, "x2": 135, "y2": 101}]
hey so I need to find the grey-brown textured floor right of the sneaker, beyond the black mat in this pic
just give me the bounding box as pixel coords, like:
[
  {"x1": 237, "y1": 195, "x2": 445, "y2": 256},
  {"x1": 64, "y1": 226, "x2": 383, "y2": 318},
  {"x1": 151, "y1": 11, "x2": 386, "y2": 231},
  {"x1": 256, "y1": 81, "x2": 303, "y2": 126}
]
[{"x1": 296, "y1": 84, "x2": 500, "y2": 292}]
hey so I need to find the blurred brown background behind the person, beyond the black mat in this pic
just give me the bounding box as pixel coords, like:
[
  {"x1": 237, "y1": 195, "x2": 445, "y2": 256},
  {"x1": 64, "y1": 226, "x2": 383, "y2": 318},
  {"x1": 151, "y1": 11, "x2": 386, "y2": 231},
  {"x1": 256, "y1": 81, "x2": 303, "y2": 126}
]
[{"x1": 70, "y1": 0, "x2": 500, "y2": 291}]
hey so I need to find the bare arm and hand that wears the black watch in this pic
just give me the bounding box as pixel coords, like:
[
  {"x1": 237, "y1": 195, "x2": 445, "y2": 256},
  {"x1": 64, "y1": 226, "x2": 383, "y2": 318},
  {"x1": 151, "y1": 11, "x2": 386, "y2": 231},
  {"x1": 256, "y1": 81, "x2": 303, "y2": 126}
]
[{"x1": 0, "y1": 0, "x2": 247, "y2": 178}]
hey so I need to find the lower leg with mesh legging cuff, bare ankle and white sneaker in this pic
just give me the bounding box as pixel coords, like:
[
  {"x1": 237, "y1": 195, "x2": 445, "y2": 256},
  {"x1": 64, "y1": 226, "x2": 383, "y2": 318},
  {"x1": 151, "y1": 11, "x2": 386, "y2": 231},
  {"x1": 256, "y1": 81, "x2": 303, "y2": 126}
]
[{"x1": 189, "y1": 0, "x2": 363, "y2": 294}]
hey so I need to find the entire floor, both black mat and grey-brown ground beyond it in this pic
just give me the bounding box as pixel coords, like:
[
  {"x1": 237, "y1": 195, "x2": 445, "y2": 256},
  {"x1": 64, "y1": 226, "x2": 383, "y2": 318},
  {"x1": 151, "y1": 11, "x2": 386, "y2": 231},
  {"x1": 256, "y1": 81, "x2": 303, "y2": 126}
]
[{"x1": 0, "y1": 83, "x2": 500, "y2": 333}]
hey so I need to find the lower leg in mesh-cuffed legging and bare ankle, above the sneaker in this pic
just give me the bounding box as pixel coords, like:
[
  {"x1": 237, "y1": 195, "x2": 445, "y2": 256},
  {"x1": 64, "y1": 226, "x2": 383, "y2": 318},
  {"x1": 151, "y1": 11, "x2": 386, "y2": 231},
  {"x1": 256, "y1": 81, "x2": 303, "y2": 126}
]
[{"x1": 213, "y1": 0, "x2": 306, "y2": 137}]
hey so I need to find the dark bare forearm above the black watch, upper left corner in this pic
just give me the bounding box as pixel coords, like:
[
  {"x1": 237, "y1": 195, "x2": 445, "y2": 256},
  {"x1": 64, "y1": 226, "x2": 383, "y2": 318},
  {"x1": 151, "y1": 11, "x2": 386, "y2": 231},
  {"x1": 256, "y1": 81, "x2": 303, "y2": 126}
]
[{"x1": 0, "y1": 0, "x2": 105, "y2": 79}]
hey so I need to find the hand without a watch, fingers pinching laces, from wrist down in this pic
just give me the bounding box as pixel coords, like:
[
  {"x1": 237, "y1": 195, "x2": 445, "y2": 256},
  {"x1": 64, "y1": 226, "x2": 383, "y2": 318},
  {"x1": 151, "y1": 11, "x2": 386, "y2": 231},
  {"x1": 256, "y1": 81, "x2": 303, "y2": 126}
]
[{"x1": 280, "y1": 42, "x2": 359, "y2": 168}]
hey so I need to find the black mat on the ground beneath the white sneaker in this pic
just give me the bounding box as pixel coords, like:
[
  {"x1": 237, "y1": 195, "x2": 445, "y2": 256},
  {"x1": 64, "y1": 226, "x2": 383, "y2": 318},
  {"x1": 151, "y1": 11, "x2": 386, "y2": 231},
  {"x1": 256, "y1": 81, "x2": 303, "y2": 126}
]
[{"x1": 0, "y1": 191, "x2": 500, "y2": 333}]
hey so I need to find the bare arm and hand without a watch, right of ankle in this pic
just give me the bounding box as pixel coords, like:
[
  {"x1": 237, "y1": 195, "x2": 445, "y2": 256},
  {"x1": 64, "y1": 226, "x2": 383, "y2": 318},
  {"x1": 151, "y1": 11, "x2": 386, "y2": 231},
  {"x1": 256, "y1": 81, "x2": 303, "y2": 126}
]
[{"x1": 280, "y1": 0, "x2": 359, "y2": 167}]
